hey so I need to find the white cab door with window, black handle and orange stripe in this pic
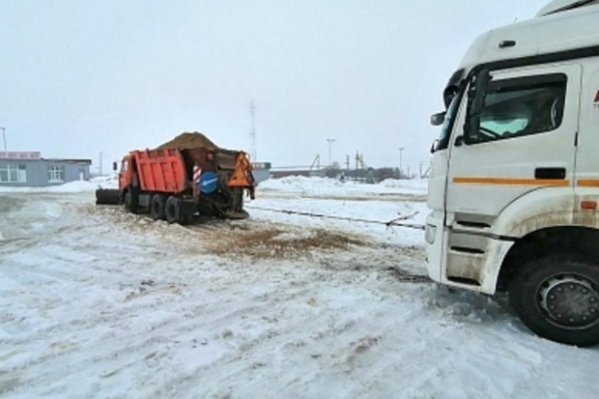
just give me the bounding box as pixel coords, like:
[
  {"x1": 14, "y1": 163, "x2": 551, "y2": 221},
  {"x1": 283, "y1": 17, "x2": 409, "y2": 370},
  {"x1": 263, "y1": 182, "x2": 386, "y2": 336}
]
[{"x1": 445, "y1": 63, "x2": 582, "y2": 228}]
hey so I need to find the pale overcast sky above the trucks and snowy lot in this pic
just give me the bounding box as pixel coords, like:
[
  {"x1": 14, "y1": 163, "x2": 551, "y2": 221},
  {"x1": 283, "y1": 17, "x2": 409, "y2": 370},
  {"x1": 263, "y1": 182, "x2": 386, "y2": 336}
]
[{"x1": 0, "y1": 0, "x2": 548, "y2": 171}]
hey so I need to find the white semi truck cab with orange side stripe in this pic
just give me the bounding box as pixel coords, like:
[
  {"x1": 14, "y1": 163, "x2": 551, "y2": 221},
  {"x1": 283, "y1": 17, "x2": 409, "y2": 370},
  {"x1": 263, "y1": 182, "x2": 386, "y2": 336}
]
[{"x1": 425, "y1": 0, "x2": 599, "y2": 346}]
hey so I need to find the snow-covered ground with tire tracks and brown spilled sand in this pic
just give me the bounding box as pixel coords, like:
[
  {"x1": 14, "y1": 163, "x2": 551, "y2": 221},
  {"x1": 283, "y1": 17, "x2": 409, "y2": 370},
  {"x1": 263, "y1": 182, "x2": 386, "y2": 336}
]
[{"x1": 0, "y1": 178, "x2": 599, "y2": 399}]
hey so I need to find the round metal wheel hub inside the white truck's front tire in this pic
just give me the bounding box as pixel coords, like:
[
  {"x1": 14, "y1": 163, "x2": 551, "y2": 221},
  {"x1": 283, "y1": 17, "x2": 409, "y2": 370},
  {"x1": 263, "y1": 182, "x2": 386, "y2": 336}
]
[{"x1": 538, "y1": 276, "x2": 599, "y2": 329}]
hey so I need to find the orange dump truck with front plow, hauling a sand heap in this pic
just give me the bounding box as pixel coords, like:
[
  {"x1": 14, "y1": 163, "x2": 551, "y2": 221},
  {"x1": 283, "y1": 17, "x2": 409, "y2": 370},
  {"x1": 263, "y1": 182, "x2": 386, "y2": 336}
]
[{"x1": 96, "y1": 147, "x2": 255, "y2": 224}]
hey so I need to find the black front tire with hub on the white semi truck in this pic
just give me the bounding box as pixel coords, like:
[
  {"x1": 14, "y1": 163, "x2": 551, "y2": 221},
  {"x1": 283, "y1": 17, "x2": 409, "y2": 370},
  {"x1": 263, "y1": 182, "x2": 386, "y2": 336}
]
[{"x1": 509, "y1": 254, "x2": 599, "y2": 347}]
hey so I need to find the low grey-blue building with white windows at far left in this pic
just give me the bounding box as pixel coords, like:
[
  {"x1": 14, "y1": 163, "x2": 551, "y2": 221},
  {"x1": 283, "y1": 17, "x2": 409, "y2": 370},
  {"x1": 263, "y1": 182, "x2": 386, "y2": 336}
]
[{"x1": 0, "y1": 152, "x2": 92, "y2": 187}]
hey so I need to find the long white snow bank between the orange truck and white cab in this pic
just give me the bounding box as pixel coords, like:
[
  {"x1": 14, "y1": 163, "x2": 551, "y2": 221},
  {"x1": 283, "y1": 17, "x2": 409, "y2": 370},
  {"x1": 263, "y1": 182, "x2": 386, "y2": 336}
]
[{"x1": 259, "y1": 176, "x2": 427, "y2": 196}]
